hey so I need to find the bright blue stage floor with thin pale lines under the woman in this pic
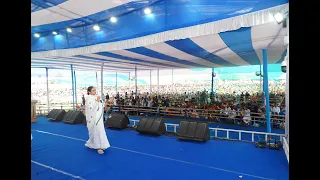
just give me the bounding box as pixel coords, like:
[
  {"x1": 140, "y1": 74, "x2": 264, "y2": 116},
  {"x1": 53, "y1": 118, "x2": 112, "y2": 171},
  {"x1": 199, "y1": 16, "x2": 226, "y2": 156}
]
[{"x1": 31, "y1": 117, "x2": 289, "y2": 180}]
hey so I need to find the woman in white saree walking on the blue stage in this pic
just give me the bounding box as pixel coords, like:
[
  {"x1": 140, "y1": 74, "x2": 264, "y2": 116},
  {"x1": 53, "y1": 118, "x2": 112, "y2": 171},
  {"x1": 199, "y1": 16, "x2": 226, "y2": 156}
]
[{"x1": 85, "y1": 86, "x2": 110, "y2": 154}]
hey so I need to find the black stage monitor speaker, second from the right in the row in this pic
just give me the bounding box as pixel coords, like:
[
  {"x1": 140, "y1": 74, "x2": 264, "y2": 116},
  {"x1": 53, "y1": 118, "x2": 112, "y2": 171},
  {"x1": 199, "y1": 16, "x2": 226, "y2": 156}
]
[{"x1": 136, "y1": 117, "x2": 166, "y2": 136}]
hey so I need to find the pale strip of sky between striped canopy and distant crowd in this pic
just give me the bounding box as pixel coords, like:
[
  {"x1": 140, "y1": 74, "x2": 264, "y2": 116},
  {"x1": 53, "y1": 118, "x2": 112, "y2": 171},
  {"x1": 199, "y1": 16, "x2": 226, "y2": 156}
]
[{"x1": 31, "y1": 64, "x2": 285, "y2": 86}]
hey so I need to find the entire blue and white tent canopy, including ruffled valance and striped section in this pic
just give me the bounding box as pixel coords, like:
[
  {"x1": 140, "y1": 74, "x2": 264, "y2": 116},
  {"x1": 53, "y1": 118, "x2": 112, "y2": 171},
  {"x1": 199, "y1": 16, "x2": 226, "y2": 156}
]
[{"x1": 31, "y1": 0, "x2": 288, "y2": 72}]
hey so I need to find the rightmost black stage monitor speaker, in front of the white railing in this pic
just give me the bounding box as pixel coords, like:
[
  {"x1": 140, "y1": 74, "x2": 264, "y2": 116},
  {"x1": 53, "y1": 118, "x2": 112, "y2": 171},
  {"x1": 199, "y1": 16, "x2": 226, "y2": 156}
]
[{"x1": 177, "y1": 121, "x2": 210, "y2": 142}]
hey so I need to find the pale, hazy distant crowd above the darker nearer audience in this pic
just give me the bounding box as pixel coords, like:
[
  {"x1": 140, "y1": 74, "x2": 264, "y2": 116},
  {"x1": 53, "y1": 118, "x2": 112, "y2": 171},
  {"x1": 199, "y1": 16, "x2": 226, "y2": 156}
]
[{"x1": 31, "y1": 80, "x2": 285, "y2": 104}]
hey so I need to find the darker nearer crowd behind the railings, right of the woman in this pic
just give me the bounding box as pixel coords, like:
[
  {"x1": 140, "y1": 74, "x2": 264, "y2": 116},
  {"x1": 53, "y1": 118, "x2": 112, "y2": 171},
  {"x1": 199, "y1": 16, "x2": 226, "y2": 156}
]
[{"x1": 87, "y1": 91, "x2": 285, "y2": 128}]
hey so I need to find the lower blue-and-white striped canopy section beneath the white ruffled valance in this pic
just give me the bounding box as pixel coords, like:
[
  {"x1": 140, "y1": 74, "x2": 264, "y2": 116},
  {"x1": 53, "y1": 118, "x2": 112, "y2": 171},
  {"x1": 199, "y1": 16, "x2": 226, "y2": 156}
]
[{"x1": 32, "y1": 22, "x2": 286, "y2": 70}]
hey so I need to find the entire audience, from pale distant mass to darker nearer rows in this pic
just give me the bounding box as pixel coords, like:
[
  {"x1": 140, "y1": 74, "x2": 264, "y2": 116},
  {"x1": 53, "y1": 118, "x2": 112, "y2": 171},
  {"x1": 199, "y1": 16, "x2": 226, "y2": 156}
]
[{"x1": 32, "y1": 80, "x2": 285, "y2": 128}]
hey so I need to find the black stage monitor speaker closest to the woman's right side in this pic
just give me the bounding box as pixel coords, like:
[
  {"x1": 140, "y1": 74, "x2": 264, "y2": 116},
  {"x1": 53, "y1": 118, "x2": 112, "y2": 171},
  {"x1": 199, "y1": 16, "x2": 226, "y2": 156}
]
[{"x1": 105, "y1": 114, "x2": 130, "y2": 129}]
